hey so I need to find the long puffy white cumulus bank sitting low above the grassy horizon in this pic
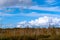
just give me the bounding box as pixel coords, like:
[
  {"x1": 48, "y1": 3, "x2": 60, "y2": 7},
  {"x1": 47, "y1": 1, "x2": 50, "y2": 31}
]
[{"x1": 17, "y1": 16, "x2": 60, "y2": 28}]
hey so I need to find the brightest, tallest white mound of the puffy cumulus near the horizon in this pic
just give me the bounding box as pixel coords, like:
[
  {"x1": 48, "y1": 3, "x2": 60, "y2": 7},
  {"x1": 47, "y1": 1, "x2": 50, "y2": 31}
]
[{"x1": 29, "y1": 16, "x2": 49, "y2": 26}]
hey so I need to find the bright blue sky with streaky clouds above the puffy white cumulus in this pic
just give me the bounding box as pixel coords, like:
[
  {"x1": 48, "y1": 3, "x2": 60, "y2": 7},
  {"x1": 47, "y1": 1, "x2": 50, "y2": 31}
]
[{"x1": 0, "y1": 0, "x2": 60, "y2": 28}]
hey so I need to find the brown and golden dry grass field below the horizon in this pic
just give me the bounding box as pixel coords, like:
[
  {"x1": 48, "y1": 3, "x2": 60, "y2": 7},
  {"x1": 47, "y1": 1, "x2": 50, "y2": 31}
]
[{"x1": 0, "y1": 28, "x2": 60, "y2": 40}]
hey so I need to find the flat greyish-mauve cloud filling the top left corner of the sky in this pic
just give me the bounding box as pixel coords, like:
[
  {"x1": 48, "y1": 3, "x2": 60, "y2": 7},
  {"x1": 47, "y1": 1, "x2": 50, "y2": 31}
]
[{"x1": 0, "y1": 0, "x2": 32, "y2": 7}]
